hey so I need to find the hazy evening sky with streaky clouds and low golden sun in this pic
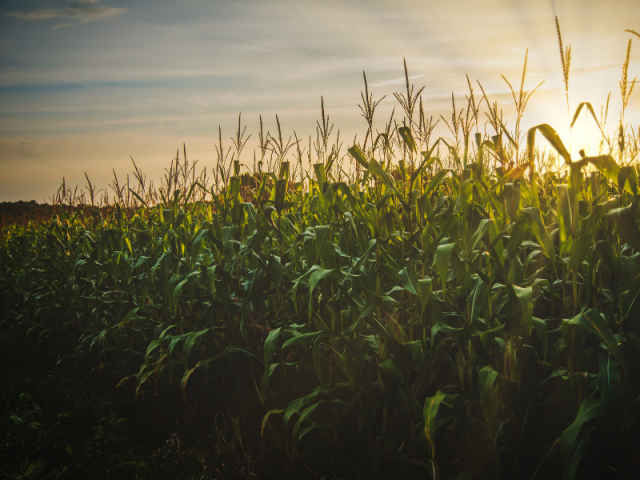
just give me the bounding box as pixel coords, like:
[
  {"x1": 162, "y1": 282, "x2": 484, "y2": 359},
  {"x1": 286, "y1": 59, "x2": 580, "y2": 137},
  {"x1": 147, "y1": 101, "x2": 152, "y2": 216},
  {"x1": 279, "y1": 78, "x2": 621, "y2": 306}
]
[{"x1": 0, "y1": 0, "x2": 640, "y2": 203}]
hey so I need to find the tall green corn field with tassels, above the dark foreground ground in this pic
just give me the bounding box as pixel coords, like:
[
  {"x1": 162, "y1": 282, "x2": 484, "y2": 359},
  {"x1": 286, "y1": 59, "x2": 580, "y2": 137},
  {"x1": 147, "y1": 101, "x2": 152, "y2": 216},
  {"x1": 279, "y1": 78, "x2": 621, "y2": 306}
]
[{"x1": 0, "y1": 25, "x2": 640, "y2": 479}]
